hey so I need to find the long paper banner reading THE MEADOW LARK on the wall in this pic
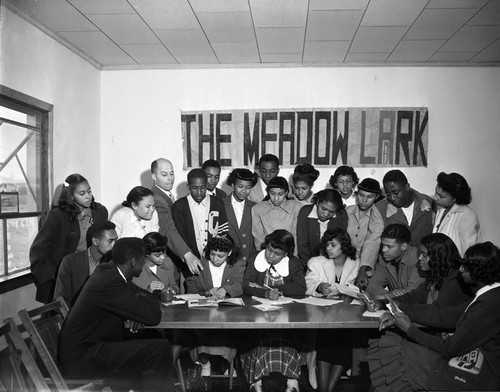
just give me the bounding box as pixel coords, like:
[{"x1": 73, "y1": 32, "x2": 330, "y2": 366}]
[{"x1": 181, "y1": 108, "x2": 429, "y2": 169}]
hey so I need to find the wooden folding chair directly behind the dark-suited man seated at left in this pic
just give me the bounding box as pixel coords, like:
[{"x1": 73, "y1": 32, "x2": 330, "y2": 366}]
[{"x1": 18, "y1": 297, "x2": 97, "y2": 392}]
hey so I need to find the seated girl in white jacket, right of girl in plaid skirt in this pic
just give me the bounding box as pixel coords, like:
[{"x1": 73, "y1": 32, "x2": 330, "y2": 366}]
[{"x1": 306, "y1": 229, "x2": 359, "y2": 392}]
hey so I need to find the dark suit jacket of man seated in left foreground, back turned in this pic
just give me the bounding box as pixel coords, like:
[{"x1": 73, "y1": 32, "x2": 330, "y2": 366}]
[{"x1": 58, "y1": 262, "x2": 161, "y2": 377}]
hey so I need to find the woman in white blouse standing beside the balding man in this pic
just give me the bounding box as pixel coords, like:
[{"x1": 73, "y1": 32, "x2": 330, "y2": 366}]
[{"x1": 111, "y1": 186, "x2": 160, "y2": 238}]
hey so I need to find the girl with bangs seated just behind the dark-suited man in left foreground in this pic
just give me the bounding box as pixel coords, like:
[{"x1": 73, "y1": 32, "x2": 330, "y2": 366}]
[{"x1": 132, "y1": 232, "x2": 179, "y2": 294}]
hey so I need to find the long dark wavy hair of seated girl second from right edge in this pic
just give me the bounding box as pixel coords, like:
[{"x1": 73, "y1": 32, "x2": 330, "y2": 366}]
[{"x1": 420, "y1": 233, "x2": 462, "y2": 290}]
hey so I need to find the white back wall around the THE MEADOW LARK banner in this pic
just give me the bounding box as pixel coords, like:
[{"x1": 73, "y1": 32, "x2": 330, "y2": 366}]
[{"x1": 101, "y1": 67, "x2": 500, "y2": 244}]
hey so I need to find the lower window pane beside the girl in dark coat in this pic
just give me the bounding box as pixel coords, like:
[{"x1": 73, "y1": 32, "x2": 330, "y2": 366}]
[{"x1": 0, "y1": 217, "x2": 38, "y2": 275}]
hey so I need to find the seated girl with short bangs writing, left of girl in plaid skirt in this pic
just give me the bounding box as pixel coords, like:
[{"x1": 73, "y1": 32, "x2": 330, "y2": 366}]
[{"x1": 186, "y1": 234, "x2": 245, "y2": 391}]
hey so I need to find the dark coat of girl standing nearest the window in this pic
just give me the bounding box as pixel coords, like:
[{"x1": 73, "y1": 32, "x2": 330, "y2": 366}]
[{"x1": 30, "y1": 203, "x2": 108, "y2": 303}]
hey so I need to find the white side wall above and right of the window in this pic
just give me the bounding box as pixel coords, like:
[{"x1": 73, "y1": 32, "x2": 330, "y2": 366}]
[{"x1": 0, "y1": 7, "x2": 101, "y2": 199}]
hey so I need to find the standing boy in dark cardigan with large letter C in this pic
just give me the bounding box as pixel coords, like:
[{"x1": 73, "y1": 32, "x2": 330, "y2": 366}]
[{"x1": 172, "y1": 169, "x2": 228, "y2": 262}]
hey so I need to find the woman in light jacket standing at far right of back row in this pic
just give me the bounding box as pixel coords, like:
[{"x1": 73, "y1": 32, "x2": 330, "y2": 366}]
[{"x1": 432, "y1": 172, "x2": 481, "y2": 256}]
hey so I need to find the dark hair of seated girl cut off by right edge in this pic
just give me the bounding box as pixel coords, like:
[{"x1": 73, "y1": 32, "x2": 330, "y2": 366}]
[{"x1": 462, "y1": 241, "x2": 500, "y2": 285}]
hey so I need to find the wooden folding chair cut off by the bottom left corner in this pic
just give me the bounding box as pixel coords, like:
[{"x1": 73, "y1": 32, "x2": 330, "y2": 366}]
[{"x1": 0, "y1": 318, "x2": 50, "y2": 392}]
